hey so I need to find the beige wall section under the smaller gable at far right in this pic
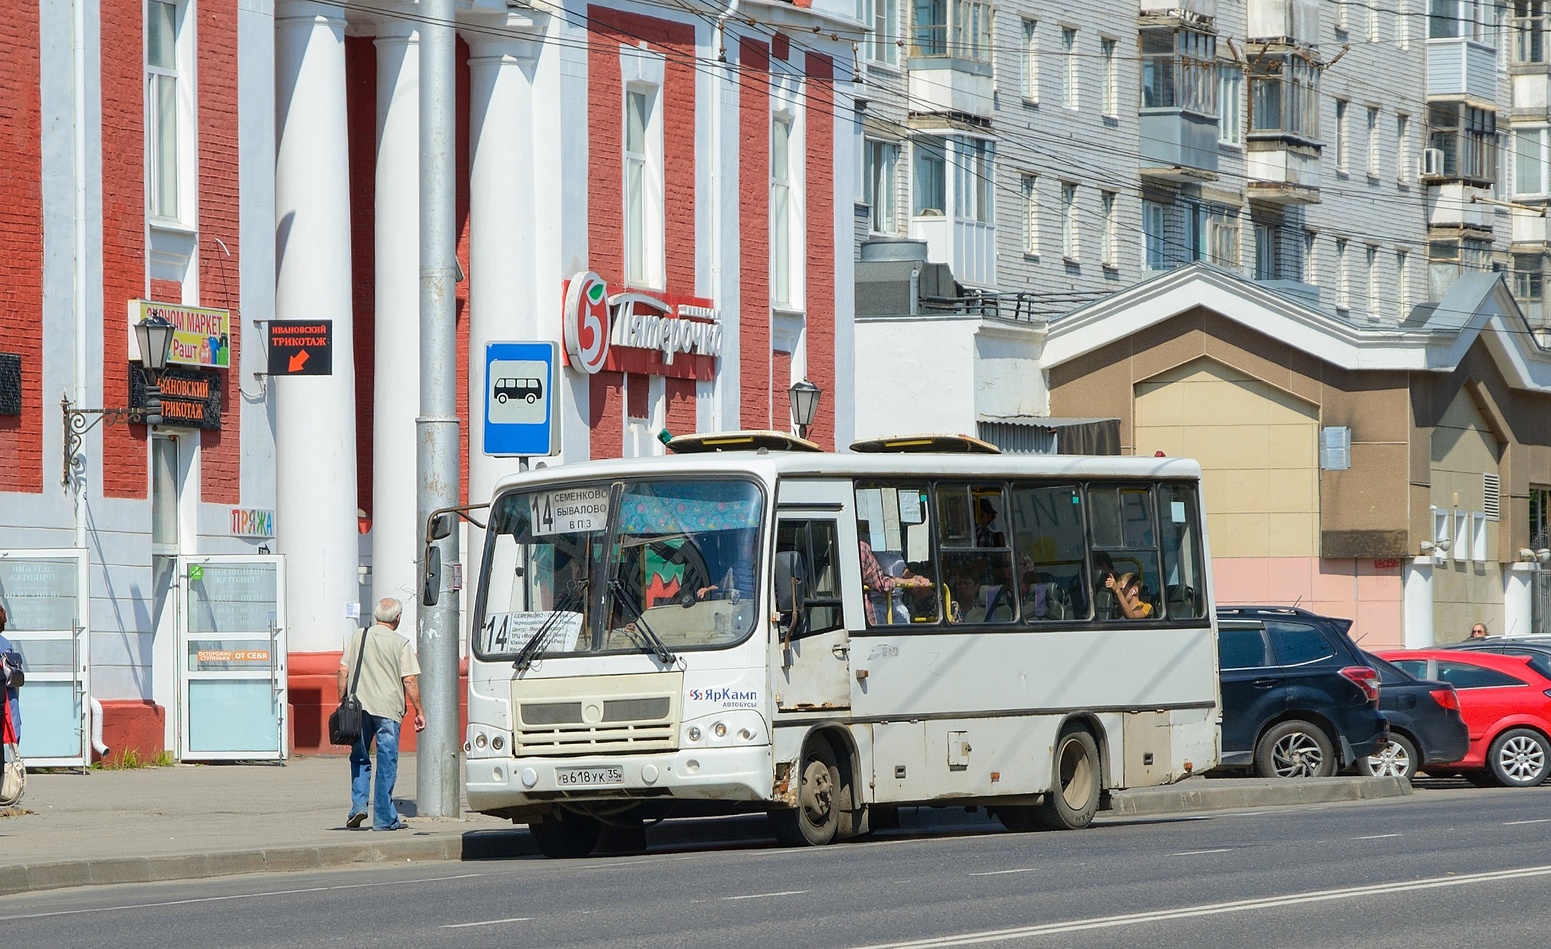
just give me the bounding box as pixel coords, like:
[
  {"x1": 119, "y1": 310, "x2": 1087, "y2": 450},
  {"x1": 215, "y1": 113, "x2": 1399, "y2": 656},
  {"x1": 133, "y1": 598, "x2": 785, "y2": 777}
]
[{"x1": 1430, "y1": 389, "x2": 1501, "y2": 642}]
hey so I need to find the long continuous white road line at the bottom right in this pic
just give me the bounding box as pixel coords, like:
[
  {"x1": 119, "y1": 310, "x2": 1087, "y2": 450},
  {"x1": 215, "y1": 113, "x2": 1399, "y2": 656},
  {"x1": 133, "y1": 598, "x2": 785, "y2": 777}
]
[{"x1": 856, "y1": 867, "x2": 1551, "y2": 949}]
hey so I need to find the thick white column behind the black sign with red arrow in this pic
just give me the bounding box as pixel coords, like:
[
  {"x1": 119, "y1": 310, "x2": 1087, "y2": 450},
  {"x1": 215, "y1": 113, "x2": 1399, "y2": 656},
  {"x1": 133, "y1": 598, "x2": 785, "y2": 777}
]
[{"x1": 270, "y1": 0, "x2": 360, "y2": 653}]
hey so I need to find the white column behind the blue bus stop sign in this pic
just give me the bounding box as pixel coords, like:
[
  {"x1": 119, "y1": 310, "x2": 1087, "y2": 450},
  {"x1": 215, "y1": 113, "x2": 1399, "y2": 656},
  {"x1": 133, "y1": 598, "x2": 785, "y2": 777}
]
[{"x1": 465, "y1": 34, "x2": 539, "y2": 567}]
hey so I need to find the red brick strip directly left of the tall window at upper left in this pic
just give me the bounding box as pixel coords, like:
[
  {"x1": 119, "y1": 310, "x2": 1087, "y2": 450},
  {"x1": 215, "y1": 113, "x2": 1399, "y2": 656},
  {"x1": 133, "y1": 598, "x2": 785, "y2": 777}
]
[{"x1": 99, "y1": 3, "x2": 147, "y2": 498}]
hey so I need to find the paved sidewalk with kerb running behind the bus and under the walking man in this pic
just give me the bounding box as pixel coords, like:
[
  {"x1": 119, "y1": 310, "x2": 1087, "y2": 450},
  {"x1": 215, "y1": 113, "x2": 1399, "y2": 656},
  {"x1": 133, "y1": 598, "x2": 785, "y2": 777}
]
[{"x1": 0, "y1": 754, "x2": 1411, "y2": 895}]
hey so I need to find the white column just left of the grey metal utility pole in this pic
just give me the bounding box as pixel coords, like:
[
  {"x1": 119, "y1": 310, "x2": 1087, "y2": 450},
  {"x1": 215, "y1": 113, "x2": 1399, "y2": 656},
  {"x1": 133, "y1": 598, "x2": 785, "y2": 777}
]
[{"x1": 370, "y1": 22, "x2": 423, "y2": 630}]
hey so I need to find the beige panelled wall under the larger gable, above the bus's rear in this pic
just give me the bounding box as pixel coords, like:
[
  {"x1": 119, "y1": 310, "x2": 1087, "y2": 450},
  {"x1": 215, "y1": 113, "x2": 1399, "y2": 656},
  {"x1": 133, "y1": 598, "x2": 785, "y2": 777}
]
[{"x1": 1134, "y1": 358, "x2": 1320, "y2": 558}]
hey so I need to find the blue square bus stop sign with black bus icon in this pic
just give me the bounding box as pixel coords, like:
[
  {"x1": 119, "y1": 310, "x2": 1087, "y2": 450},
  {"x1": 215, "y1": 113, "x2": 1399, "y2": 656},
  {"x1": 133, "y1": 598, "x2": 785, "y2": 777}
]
[{"x1": 484, "y1": 343, "x2": 560, "y2": 457}]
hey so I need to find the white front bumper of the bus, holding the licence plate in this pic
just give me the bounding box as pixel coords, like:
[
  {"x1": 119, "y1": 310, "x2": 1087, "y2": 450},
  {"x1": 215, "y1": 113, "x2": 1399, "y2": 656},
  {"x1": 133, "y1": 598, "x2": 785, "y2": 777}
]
[{"x1": 464, "y1": 744, "x2": 774, "y2": 813}]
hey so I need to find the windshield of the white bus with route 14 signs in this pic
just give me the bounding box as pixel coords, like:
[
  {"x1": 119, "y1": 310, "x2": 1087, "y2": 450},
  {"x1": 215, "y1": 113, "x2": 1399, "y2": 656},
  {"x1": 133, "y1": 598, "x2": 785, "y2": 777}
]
[{"x1": 475, "y1": 479, "x2": 765, "y2": 664}]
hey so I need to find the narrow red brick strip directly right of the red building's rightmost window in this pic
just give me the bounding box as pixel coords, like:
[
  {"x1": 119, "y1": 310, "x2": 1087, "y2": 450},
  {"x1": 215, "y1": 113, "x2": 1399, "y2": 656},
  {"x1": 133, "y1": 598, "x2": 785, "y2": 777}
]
[{"x1": 806, "y1": 53, "x2": 836, "y2": 450}]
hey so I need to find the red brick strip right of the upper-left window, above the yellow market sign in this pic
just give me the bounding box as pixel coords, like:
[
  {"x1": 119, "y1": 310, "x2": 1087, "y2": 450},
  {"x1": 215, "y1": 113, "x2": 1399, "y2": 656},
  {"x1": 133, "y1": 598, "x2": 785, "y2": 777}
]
[{"x1": 191, "y1": 0, "x2": 242, "y2": 504}]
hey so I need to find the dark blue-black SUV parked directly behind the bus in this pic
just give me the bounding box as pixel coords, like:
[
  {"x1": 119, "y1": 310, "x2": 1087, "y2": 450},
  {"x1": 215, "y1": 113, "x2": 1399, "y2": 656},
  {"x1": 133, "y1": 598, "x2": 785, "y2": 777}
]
[{"x1": 1218, "y1": 606, "x2": 1388, "y2": 777}]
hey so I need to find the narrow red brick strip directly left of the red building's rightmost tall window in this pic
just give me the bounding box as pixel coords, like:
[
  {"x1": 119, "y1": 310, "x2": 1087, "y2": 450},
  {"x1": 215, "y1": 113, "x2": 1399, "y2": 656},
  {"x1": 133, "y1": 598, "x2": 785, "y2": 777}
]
[{"x1": 738, "y1": 39, "x2": 769, "y2": 428}]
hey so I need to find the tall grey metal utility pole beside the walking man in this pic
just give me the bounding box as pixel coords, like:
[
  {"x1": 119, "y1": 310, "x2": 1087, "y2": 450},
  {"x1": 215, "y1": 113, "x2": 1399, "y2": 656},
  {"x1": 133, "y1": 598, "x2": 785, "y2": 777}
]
[{"x1": 414, "y1": 0, "x2": 461, "y2": 817}]
